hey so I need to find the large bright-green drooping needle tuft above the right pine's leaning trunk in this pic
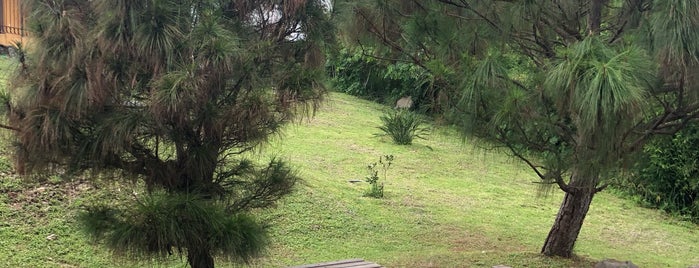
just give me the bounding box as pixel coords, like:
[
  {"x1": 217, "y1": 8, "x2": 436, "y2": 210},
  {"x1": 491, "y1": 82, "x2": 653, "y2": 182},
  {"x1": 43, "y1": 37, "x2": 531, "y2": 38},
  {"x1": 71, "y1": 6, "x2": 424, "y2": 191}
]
[{"x1": 544, "y1": 37, "x2": 656, "y2": 169}]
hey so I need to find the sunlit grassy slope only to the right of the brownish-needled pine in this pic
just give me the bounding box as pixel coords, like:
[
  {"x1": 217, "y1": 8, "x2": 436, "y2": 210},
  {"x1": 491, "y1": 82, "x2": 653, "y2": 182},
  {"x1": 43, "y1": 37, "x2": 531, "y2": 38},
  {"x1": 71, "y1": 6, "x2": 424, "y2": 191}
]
[{"x1": 254, "y1": 94, "x2": 699, "y2": 267}]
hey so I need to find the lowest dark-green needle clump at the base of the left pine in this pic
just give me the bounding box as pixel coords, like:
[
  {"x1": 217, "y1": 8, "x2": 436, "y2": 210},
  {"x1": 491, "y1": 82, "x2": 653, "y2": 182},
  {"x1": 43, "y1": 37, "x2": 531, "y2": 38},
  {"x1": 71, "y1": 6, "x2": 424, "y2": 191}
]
[{"x1": 81, "y1": 191, "x2": 267, "y2": 261}]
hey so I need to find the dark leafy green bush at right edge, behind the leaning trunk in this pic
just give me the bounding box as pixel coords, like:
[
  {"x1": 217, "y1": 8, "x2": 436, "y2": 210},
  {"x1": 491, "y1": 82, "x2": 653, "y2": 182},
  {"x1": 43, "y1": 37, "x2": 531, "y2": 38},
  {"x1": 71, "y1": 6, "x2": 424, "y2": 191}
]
[{"x1": 622, "y1": 124, "x2": 699, "y2": 222}]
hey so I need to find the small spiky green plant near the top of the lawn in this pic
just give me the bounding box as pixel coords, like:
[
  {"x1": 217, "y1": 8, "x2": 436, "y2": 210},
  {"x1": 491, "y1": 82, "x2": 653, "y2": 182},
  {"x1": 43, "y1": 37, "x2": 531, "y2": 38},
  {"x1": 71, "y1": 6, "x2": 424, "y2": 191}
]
[{"x1": 376, "y1": 110, "x2": 428, "y2": 145}]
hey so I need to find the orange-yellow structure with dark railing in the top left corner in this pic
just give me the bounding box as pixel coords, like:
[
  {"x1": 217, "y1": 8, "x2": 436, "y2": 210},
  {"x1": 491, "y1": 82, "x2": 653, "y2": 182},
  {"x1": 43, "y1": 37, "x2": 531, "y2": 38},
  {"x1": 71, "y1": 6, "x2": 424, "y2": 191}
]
[{"x1": 0, "y1": 0, "x2": 27, "y2": 47}]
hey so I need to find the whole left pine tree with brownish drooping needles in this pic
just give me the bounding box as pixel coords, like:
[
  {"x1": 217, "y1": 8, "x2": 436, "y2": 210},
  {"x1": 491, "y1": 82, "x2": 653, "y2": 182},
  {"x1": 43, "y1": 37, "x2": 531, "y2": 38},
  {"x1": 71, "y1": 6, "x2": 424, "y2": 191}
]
[{"x1": 8, "y1": 0, "x2": 333, "y2": 267}]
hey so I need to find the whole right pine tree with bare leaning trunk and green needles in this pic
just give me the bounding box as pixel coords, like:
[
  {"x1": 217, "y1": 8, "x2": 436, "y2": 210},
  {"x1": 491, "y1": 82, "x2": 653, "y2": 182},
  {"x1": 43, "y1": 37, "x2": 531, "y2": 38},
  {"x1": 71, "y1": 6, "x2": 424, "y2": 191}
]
[{"x1": 345, "y1": 0, "x2": 699, "y2": 257}]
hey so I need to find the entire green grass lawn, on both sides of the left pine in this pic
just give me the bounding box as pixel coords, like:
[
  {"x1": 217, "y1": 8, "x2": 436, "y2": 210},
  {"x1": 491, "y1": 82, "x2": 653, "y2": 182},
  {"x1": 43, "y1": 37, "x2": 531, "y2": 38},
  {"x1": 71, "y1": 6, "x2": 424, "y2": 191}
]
[{"x1": 0, "y1": 93, "x2": 699, "y2": 267}]
